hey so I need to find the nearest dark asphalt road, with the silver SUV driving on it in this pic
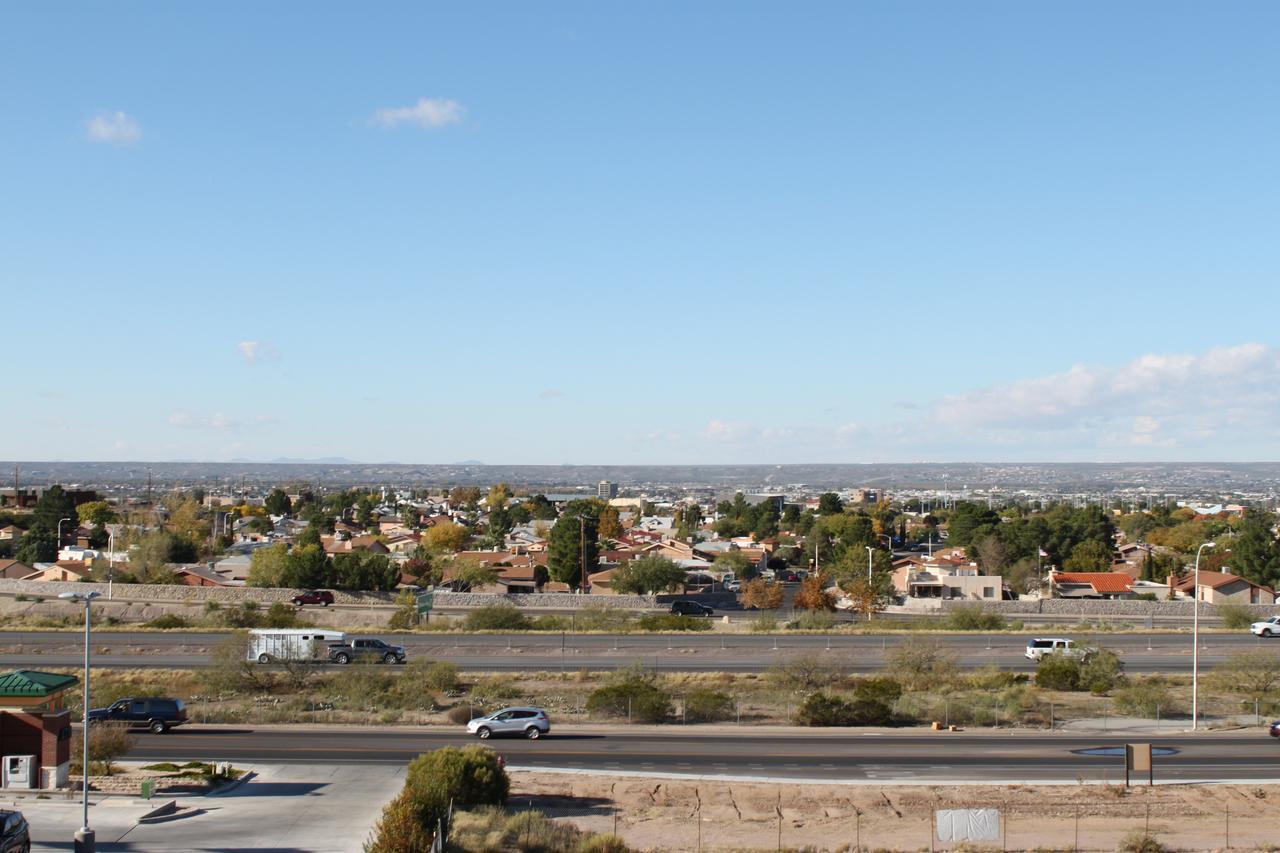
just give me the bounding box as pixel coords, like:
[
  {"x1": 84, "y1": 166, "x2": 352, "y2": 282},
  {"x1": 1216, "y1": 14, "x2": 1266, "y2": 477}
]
[{"x1": 128, "y1": 726, "x2": 1280, "y2": 783}]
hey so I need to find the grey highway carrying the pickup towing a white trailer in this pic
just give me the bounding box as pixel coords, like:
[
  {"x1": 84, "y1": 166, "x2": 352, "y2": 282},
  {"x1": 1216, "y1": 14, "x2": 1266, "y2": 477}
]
[{"x1": 0, "y1": 630, "x2": 1264, "y2": 672}]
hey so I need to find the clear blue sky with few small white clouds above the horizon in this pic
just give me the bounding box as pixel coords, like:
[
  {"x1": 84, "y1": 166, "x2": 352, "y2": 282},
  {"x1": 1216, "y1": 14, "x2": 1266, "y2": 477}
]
[{"x1": 0, "y1": 3, "x2": 1280, "y2": 464}]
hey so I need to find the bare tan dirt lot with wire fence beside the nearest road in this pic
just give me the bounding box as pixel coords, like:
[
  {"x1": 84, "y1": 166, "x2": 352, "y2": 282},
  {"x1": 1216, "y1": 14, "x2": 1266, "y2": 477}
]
[{"x1": 509, "y1": 772, "x2": 1280, "y2": 850}]
